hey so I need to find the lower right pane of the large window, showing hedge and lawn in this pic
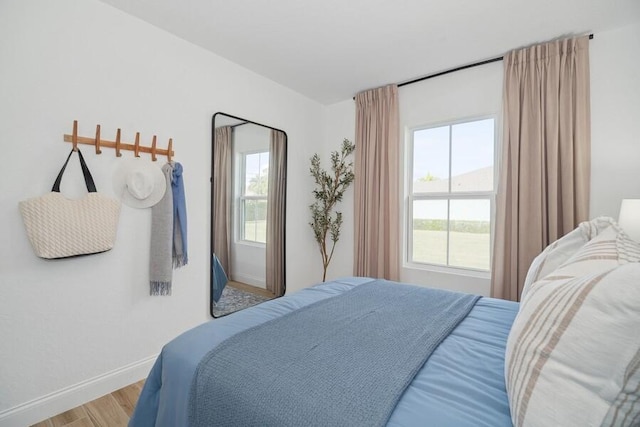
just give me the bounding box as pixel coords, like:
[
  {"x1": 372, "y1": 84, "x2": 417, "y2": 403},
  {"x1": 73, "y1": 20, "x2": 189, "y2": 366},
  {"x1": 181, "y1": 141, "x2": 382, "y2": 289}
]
[{"x1": 449, "y1": 199, "x2": 491, "y2": 270}]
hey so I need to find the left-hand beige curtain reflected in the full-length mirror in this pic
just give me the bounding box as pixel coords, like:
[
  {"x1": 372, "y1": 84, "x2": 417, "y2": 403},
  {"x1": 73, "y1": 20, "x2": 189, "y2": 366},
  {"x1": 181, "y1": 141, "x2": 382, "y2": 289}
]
[{"x1": 211, "y1": 126, "x2": 233, "y2": 276}]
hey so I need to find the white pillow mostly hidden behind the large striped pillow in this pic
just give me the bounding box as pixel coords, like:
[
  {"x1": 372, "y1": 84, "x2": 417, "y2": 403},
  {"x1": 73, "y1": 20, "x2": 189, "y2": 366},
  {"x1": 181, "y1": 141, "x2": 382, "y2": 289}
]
[{"x1": 520, "y1": 216, "x2": 615, "y2": 300}]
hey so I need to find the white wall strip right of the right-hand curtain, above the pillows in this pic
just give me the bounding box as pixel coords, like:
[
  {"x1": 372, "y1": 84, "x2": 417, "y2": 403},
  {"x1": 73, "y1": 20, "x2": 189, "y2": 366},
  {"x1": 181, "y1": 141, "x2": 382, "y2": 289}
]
[{"x1": 589, "y1": 23, "x2": 640, "y2": 219}]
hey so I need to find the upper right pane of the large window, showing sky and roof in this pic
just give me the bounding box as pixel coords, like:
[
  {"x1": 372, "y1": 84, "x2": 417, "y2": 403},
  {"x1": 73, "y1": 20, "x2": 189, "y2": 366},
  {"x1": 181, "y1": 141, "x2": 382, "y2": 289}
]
[{"x1": 451, "y1": 119, "x2": 494, "y2": 192}]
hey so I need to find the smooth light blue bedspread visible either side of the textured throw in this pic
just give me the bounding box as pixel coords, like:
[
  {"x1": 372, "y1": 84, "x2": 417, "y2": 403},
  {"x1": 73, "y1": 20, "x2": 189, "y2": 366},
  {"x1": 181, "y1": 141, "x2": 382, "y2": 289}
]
[{"x1": 130, "y1": 278, "x2": 518, "y2": 427}]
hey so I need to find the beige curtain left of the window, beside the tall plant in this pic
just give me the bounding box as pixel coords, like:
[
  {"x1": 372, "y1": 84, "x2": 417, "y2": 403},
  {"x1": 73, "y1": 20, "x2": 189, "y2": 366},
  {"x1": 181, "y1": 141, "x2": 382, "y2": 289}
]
[{"x1": 354, "y1": 85, "x2": 400, "y2": 280}]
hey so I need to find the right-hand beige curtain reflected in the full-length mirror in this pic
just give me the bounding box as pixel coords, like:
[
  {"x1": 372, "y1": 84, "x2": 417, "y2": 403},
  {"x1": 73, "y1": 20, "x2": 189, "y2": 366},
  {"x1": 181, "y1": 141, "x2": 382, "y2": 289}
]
[{"x1": 266, "y1": 129, "x2": 287, "y2": 296}]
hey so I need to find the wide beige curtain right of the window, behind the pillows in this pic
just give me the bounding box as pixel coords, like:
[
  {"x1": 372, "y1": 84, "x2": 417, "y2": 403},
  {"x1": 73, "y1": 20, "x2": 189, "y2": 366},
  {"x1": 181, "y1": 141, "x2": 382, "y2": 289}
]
[{"x1": 491, "y1": 37, "x2": 591, "y2": 301}]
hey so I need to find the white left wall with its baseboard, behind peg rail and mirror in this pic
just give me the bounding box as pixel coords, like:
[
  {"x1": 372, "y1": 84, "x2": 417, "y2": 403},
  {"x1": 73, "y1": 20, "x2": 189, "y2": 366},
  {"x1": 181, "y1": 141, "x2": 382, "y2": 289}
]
[{"x1": 0, "y1": 0, "x2": 323, "y2": 426}]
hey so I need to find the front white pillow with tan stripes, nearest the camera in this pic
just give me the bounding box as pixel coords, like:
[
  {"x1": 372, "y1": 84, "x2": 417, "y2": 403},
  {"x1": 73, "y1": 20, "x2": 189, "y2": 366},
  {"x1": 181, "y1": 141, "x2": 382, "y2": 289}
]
[{"x1": 505, "y1": 258, "x2": 640, "y2": 427}]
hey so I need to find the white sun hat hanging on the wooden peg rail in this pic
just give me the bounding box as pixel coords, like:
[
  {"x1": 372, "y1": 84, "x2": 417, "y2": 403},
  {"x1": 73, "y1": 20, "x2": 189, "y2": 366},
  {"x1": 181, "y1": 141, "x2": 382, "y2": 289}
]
[{"x1": 113, "y1": 159, "x2": 167, "y2": 209}]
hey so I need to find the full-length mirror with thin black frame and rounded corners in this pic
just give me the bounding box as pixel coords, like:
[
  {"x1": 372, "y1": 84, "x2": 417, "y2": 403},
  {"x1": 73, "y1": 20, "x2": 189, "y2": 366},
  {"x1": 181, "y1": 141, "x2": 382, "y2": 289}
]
[{"x1": 210, "y1": 113, "x2": 287, "y2": 317}]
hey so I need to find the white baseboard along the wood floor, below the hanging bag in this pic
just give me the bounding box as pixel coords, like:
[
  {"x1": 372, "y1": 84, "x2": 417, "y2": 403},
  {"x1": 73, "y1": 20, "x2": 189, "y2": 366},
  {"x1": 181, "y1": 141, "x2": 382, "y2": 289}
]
[{"x1": 0, "y1": 355, "x2": 158, "y2": 427}]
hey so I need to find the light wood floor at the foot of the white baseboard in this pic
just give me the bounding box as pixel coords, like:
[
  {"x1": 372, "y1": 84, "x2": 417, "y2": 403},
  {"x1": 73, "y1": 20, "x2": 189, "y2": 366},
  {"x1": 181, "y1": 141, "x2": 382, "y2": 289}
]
[{"x1": 31, "y1": 380, "x2": 144, "y2": 427}]
